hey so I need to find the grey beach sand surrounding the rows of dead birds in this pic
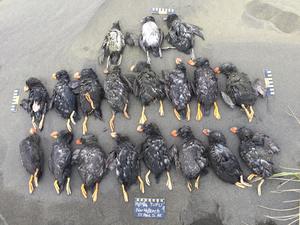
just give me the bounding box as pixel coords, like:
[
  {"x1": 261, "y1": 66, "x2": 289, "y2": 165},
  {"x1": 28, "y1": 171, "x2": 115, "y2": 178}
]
[{"x1": 0, "y1": 0, "x2": 300, "y2": 225}]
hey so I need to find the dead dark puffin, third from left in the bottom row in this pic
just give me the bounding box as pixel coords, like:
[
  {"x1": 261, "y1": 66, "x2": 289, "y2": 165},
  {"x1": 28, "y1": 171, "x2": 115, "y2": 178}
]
[{"x1": 72, "y1": 134, "x2": 107, "y2": 202}]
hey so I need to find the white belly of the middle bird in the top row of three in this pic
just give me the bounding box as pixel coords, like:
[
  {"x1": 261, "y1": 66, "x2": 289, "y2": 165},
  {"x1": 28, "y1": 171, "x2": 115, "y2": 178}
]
[{"x1": 142, "y1": 21, "x2": 160, "y2": 46}]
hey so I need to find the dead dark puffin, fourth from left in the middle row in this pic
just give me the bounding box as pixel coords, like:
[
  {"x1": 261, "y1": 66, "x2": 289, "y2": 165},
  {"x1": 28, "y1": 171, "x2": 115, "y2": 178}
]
[{"x1": 104, "y1": 67, "x2": 132, "y2": 133}]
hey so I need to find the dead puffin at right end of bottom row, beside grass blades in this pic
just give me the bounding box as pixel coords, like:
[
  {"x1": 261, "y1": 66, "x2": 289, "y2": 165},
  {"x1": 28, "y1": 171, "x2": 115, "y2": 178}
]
[{"x1": 230, "y1": 127, "x2": 280, "y2": 196}]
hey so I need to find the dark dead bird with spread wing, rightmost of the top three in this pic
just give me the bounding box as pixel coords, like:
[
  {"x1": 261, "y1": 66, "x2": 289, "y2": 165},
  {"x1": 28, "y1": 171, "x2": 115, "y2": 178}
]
[{"x1": 165, "y1": 14, "x2": 204, "y2": 59}]
